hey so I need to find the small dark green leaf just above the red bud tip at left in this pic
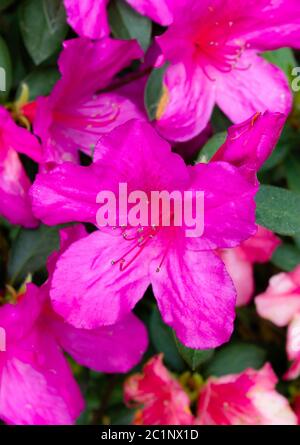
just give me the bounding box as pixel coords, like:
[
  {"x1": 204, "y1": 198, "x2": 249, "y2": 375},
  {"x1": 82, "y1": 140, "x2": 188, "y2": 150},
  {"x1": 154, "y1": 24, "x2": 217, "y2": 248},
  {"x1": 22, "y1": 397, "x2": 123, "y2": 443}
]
[{"x1": 17, "y1": 68, "x2": 60, "y2": 100}]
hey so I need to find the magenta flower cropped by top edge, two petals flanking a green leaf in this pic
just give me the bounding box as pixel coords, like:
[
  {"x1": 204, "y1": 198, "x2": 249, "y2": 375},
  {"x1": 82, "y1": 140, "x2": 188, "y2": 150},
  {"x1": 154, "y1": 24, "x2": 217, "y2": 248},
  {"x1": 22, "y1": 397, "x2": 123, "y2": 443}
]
[{"x1": 64, "y1": 0, "x2": 178, "y2": 39}]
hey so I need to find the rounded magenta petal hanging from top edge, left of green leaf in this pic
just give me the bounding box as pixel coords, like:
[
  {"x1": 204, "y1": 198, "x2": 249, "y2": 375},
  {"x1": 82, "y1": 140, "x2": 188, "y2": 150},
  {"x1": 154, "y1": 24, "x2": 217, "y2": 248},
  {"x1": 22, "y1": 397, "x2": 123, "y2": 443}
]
[{"x1": 64, "y1": 0, "x2": 109, "y2": 39}]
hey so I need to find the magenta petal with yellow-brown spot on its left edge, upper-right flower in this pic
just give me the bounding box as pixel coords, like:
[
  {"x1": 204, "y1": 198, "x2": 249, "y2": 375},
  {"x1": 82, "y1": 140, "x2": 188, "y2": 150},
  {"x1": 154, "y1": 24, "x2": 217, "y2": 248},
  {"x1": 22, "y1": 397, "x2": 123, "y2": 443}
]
[{"x1": 156, "y1": 63, "x2": 215, "y2": 141}]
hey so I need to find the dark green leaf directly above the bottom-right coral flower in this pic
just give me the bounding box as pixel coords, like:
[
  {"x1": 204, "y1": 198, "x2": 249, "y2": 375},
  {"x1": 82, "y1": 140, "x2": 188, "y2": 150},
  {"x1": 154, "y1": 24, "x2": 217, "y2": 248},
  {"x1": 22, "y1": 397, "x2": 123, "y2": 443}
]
[{"x1": 205, "y1": 342, "x2": 266, "y2": 377}]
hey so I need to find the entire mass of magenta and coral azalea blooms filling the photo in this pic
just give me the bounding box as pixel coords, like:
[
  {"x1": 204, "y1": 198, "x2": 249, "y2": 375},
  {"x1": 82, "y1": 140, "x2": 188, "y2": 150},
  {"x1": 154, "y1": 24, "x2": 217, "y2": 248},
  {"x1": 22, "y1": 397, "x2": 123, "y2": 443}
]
[{"x1": 0, "y1": 0, "x2": 300, "y2": 425}]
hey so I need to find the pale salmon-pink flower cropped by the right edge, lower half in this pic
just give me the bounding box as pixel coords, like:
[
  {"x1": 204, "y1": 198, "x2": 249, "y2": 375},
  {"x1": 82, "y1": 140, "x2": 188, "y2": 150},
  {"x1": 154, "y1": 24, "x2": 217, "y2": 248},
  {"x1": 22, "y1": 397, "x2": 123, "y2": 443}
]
[{"x1": 255, "y1": 266, "x2": 300, "y2": 379}]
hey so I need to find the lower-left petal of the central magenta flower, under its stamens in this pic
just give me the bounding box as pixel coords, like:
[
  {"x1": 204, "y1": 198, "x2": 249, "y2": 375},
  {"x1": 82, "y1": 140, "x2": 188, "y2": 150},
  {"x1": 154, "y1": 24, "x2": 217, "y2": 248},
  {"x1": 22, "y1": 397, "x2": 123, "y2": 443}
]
[{"x1": 50, "y1": 231, "x2": 149, "y2": 329}]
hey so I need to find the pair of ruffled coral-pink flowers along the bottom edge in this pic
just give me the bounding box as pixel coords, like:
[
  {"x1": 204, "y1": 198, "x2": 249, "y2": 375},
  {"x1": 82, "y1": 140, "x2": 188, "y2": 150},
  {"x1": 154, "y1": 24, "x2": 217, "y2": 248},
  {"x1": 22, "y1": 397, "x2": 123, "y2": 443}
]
[{"x1": 125, "y1": 356, "x2": 297, "y2": 425}]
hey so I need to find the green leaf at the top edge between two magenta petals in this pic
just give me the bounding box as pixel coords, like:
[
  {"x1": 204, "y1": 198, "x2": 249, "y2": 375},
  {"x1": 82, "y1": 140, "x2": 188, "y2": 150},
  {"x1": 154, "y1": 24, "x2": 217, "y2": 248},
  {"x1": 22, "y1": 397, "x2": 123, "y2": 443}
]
[{"x1": 108, "y1": 0, "x2": 152, "y2": 51}]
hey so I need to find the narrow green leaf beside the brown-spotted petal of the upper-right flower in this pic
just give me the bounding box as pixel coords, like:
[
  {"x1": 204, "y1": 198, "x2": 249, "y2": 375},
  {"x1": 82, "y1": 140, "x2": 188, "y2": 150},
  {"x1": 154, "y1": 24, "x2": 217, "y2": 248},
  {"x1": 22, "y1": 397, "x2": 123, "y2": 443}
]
[{"x1": 144, "y1": 64, "x2": 168, "y2": 121}]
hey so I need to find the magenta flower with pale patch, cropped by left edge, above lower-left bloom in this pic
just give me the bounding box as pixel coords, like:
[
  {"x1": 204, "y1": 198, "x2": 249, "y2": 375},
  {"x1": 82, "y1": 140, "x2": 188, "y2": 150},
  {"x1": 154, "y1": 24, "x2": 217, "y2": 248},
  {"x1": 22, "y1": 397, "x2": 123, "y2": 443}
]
[{"x1": 0, "y1": 106, "x2": 42, "y2": 227}]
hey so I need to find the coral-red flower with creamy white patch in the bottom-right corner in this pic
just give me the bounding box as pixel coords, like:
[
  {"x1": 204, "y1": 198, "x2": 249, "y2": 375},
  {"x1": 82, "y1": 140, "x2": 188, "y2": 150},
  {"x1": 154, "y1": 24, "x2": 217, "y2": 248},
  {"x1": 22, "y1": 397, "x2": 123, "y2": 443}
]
[{"x1": 196, "y1": 364, "x2": 297, "y2": 425}]
